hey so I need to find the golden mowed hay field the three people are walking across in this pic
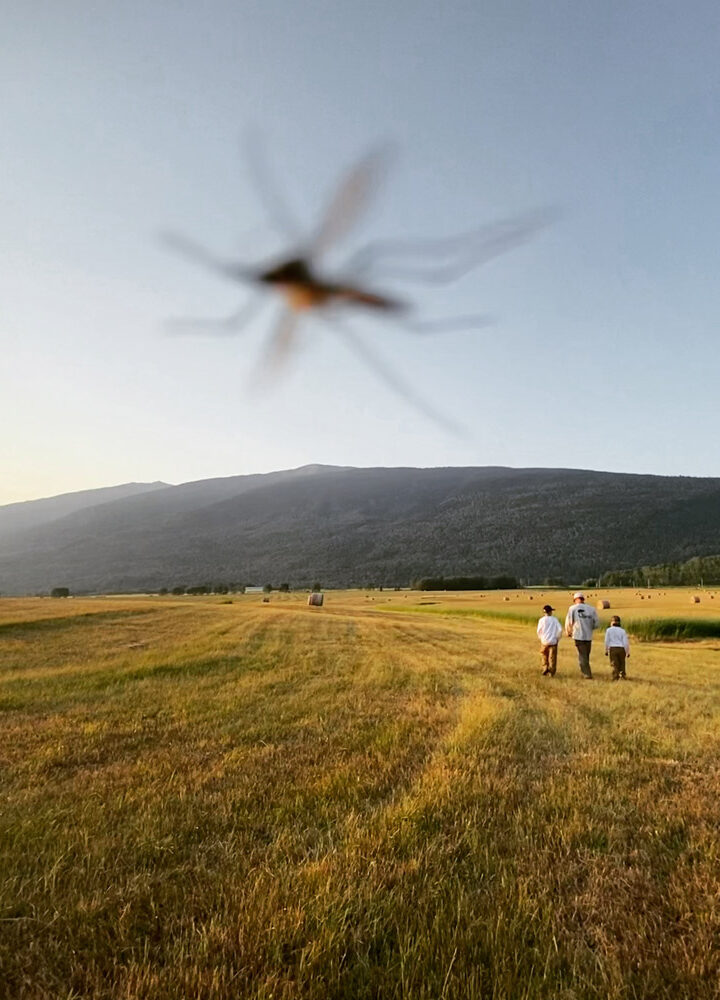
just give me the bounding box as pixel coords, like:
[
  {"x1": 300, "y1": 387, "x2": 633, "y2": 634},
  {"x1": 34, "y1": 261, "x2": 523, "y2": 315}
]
[{"x1": 0, "y1": 591, "x2": 720, "y2": 1000}]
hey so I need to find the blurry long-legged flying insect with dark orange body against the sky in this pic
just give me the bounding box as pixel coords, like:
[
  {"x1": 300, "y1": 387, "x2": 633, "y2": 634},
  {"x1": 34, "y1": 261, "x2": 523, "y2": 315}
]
[{"x1": 164, "y1": 138, "x2": 552, "y2": 431}]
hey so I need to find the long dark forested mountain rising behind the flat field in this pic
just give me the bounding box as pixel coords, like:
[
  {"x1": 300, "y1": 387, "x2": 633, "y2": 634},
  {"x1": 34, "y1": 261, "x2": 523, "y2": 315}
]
[{"x1": 0, "y1": 466, "x2": 720, "y2": 594}]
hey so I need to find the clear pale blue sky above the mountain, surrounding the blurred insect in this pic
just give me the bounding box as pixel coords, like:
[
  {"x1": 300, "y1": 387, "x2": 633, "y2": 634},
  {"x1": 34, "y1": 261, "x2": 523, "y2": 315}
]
[{"x1": 0, "y1": 0, "x2": 720, "y2": 503}]
